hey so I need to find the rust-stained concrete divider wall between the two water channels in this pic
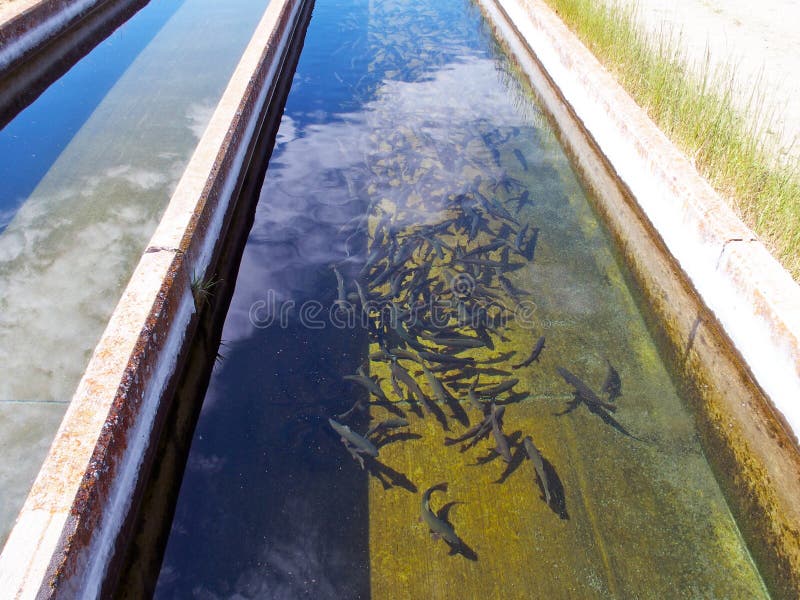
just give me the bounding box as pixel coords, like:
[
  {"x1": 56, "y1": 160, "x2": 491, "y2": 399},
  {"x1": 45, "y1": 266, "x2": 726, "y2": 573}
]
[{"x1": 0, "y1": 0, "x2": 304, "y2": 598}]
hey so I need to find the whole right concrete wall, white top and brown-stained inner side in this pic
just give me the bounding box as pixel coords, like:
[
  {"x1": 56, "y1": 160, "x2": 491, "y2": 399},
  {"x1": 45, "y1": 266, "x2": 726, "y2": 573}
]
[{"x1": 480, "y1": 0, "x2": 800, "y2": 598}]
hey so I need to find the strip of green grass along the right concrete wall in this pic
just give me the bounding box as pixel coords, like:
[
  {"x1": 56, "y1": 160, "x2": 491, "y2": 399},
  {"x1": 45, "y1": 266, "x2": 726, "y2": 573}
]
[{"x1": 546, "y1": 0, "x2": 800, "y2": 281}]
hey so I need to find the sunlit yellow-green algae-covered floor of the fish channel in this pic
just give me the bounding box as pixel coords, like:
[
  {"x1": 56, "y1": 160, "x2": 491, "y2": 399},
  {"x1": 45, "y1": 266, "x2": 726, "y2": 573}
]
[{"x1": 360, "y1": 140, "x2": 767, "y2": 598}]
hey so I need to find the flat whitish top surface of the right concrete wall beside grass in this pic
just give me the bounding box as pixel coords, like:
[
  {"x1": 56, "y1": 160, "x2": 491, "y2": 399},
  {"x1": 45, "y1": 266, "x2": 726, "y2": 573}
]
[{"x1": 488, "y1": 0, "x2": 800, "y2": 434}]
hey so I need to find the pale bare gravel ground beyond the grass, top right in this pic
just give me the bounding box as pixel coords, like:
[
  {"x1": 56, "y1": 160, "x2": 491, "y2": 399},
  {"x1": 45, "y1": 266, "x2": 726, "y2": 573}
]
[{"x1": 616, "y1": 0, "x2": 800, "y2": 157}]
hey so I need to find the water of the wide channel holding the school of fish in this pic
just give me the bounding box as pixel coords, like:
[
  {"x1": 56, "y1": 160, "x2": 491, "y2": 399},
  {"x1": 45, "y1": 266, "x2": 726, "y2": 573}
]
[{"x1": 156, "y1": 0, "x2": 766, "y2": 598}]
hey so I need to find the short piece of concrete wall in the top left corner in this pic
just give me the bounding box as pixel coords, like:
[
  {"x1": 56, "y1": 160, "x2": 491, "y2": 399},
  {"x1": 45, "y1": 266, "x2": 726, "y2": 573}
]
[{"x1": 0, "y1": 0, "x2": 112, "y2": 73}]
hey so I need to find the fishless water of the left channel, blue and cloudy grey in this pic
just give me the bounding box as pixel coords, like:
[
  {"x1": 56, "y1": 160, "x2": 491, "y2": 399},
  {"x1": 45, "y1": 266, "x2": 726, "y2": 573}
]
[{"x1": 0, "y1": 0, "x2": 267, "y2": 542}]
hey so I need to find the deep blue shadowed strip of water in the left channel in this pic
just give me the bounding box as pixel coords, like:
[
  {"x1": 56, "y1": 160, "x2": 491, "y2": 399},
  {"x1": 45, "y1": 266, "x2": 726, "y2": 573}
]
[{"x1": 0, "y1": 0, "x2": 185, "y2": 233}]
